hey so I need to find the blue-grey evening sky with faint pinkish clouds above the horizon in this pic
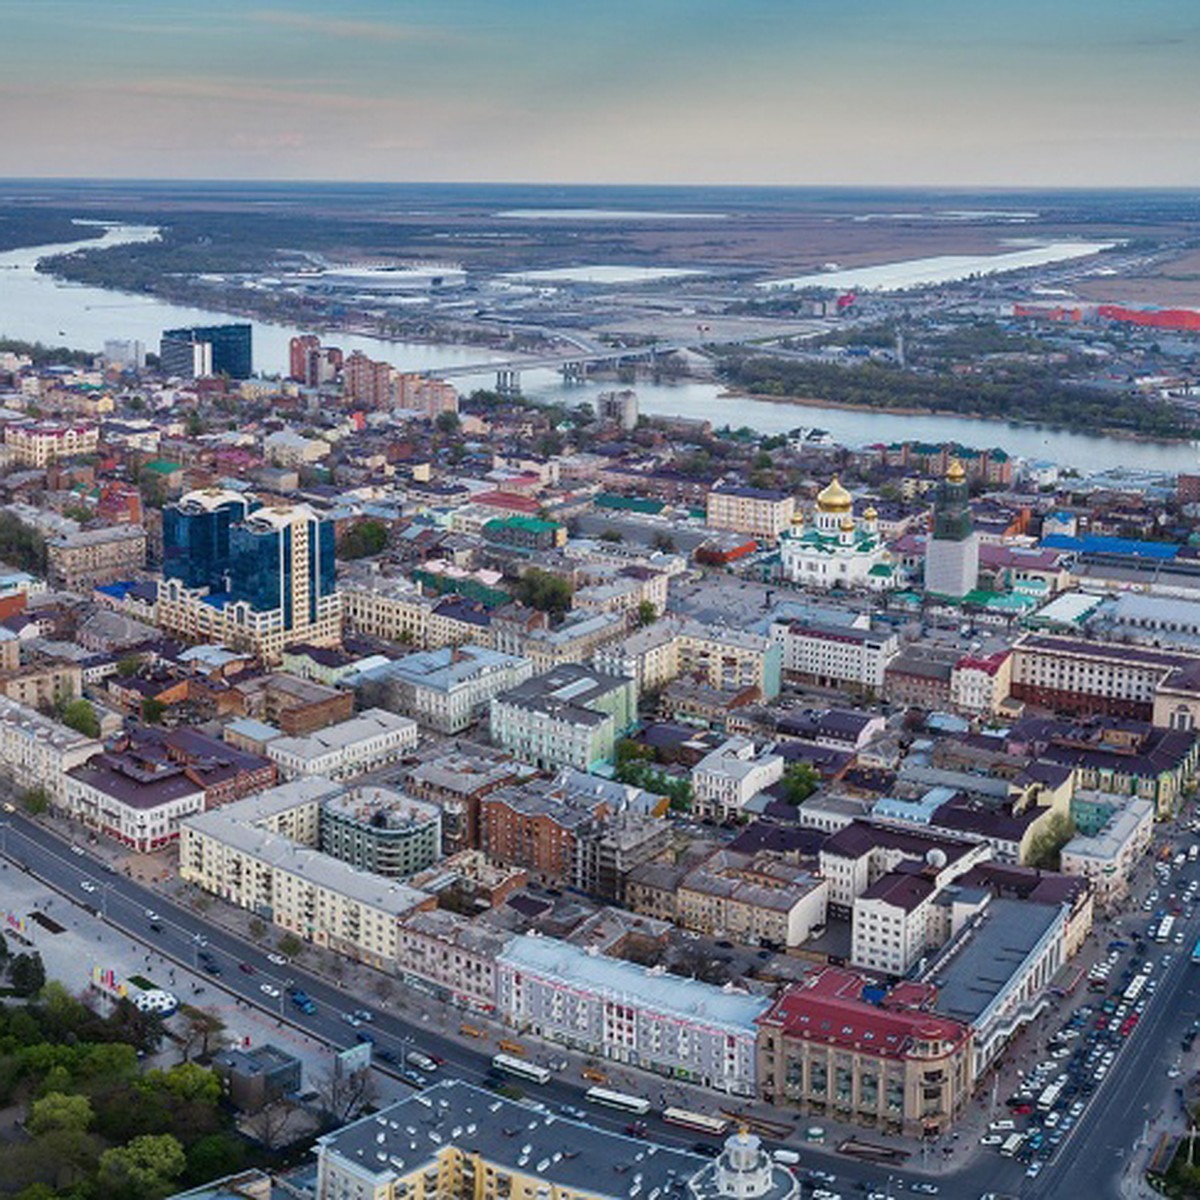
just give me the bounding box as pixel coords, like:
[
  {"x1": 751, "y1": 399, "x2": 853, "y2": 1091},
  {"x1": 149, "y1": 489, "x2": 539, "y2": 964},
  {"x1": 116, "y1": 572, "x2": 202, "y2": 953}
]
[{"x1": 0, "y1": 0, "x2": 1200, "y2": 187}]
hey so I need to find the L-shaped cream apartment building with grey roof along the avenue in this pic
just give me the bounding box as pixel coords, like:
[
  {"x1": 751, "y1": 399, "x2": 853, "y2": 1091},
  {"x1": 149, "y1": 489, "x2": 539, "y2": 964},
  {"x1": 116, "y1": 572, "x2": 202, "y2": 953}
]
[{"x1": 179, "y1": 778, "x2": 437, "y2": 972}]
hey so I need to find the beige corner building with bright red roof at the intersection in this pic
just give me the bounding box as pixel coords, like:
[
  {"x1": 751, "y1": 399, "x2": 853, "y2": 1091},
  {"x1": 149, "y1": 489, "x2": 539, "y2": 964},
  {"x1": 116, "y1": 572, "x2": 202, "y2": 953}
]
[{"x1": 758, "y1": 967, "x2": 976, "y2": 1136}]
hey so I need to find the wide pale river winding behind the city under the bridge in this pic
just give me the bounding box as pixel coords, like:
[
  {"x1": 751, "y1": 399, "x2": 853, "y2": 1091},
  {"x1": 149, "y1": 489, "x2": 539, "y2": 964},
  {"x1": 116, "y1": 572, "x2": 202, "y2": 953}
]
[{"x1": 0, "y1": 226, "x2": 1200, "y2": 473}]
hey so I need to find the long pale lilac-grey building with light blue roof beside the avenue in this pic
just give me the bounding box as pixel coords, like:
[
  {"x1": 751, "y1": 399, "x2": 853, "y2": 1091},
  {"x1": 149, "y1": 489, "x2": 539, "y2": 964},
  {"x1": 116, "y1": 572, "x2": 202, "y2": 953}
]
[{"x1": 497, "y1": 934, "x2": 769, "y2": 1096}]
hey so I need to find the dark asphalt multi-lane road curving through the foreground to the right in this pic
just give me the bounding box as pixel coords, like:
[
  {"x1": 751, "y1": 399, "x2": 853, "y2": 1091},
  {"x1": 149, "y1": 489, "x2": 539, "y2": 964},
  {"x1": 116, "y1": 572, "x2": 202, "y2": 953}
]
[{"x1": 0, "y1": 814, "x2": 1200, "y2": 1200}]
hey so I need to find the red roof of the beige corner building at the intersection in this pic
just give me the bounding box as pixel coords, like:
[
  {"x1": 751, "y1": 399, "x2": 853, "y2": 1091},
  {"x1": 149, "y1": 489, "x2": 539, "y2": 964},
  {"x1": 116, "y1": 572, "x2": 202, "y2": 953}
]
[{"x1": 760, "y1": 967, "x2": 971, "y2": 1058}]
